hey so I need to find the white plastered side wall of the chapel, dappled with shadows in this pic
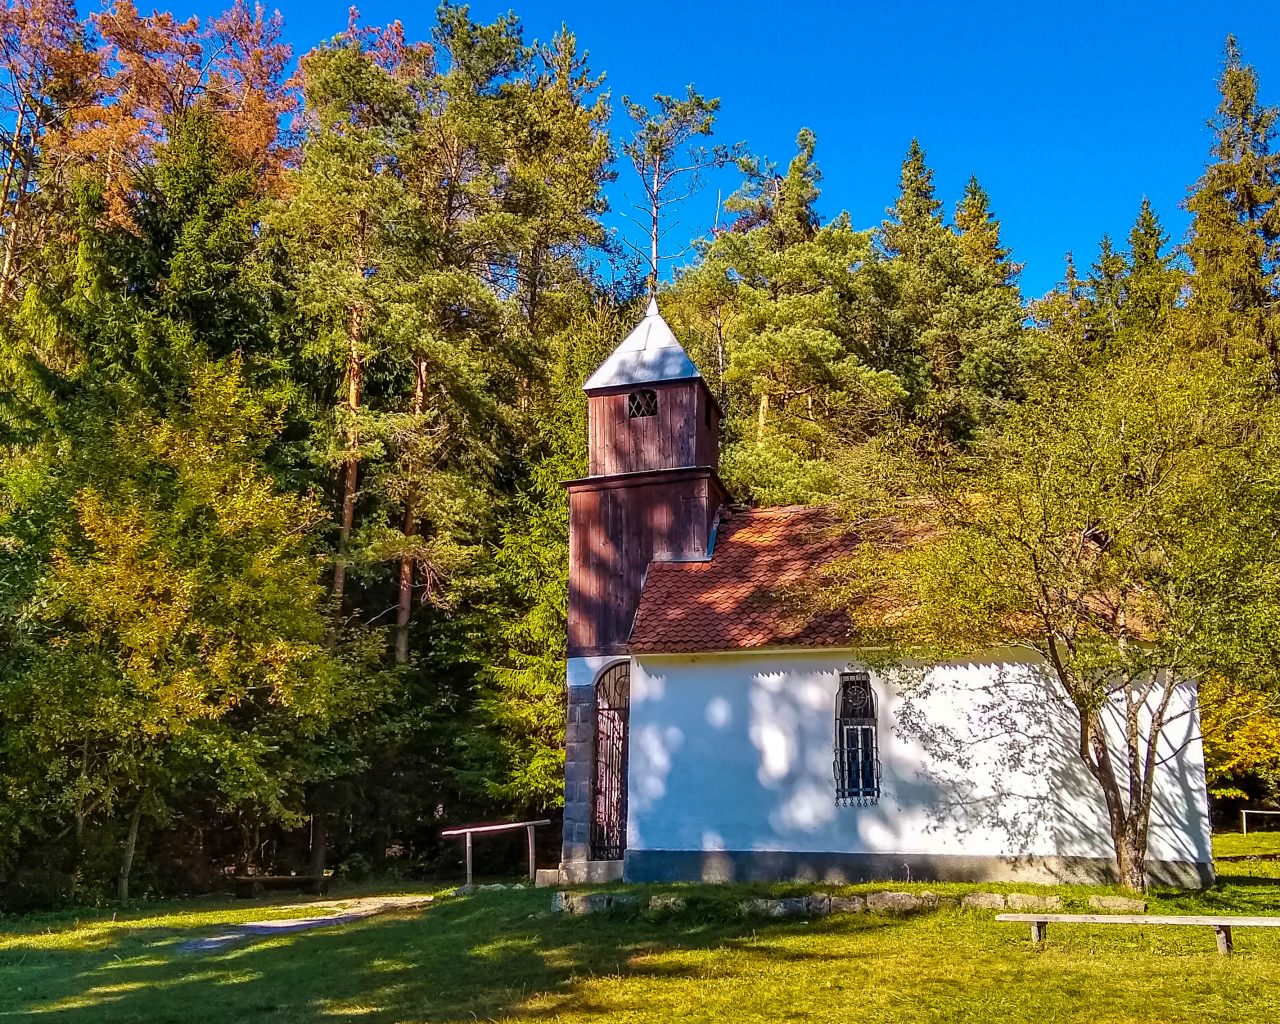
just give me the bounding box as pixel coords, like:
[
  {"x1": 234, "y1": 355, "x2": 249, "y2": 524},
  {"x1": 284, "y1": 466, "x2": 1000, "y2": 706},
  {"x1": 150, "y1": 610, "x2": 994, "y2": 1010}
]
[{"x1": 627, "y1": 652, "x2": 1210, "y2": 863}]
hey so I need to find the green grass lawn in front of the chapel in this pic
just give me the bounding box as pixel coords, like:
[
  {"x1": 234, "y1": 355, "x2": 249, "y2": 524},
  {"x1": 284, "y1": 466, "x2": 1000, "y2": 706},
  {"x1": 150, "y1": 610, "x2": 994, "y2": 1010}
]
[{"x1": 0, "y1": 861, "x2": 1280, "y2": 1024}]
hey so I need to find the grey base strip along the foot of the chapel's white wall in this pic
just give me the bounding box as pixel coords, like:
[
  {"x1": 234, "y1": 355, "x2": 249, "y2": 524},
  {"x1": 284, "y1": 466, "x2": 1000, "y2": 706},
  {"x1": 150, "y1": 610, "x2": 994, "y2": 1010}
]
[{"x1": 623, "y1": 850, "x2": 1213, "y2": 888}]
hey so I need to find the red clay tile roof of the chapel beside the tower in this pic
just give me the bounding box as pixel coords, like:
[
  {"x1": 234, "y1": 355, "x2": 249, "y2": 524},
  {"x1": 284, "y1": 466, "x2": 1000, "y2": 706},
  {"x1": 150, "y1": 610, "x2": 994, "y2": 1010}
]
[{"x1": 630, "y1": 506, "x2": 860, "y2": 653}]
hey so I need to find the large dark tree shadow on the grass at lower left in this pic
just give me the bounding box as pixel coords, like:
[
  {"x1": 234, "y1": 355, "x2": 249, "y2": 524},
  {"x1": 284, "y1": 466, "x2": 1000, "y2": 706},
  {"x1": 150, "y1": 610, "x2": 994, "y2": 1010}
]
[{"x1": 0, "y1": 890, "x2": 897, "y2": 1024}]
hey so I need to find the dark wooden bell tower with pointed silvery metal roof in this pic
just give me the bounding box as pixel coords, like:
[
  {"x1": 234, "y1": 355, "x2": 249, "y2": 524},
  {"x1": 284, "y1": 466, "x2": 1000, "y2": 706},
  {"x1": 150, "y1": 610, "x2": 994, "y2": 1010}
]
[{"x1": 567, "y1": 300, "x2": 726, "y2": 658}]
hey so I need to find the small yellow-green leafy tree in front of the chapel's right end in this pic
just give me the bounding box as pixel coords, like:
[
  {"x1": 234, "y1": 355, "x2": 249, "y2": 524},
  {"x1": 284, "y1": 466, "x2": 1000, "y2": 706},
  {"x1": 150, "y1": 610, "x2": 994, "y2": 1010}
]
[{"x1": 849, "y1": 347, "x2": 1280, "y2": 888}]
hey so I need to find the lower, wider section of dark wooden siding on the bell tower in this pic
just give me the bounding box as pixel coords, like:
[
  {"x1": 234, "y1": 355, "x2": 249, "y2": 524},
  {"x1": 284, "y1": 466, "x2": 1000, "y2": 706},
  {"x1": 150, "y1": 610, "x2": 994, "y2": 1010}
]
[{"x1": 568, "y1": 471, "x2": 724, "y2": 657}]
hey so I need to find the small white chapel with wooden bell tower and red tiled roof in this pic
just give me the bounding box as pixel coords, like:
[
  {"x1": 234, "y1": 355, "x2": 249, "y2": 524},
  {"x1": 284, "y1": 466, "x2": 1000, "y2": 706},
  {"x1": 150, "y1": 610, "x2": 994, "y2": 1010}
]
[{"x1": 558, "y1": 301, "x2": 1212, "y2": 884}]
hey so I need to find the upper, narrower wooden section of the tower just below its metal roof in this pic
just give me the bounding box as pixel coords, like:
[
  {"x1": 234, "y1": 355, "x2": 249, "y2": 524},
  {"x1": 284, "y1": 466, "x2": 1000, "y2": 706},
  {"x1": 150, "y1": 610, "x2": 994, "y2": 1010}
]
[{"x1": 588, "y1": 380, "x2": 719, "y2": 476}]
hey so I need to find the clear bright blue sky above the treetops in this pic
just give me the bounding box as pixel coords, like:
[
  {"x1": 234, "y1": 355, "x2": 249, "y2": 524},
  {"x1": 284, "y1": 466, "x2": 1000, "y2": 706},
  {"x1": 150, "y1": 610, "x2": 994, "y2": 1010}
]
[{"x1": 202, "y1": 0, "x2": 1280, "y2": 297}]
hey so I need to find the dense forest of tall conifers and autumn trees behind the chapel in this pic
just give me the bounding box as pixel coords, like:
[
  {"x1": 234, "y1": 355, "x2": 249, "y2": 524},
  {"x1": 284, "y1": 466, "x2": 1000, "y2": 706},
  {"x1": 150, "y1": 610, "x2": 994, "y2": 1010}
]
[{"x1": 0, "y1": 0, "x2": 1280, "y2": 909}]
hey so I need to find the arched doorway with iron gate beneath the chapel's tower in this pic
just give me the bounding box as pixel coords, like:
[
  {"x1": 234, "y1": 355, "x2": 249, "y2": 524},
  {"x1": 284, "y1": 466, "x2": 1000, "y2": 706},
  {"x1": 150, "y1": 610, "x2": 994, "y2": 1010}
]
[{"x1": 591, "y1": 662, "x2": 631, "y2": 860}]
